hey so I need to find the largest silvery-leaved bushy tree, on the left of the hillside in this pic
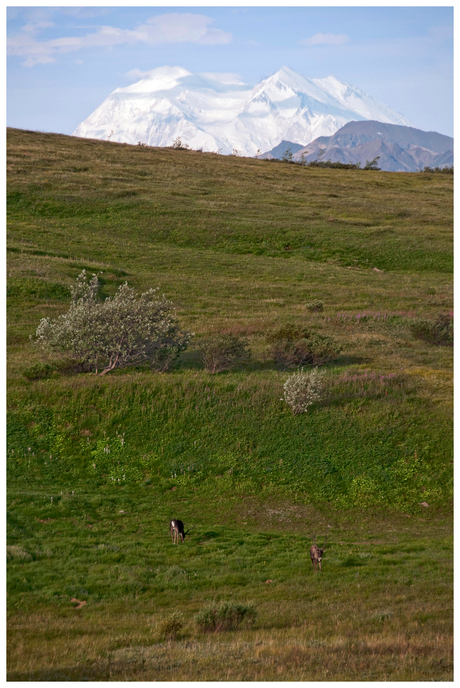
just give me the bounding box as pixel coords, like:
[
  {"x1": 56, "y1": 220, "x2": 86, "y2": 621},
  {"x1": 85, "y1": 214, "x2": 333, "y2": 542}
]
[{"x1": 35, "y1": 270, "x2": 191, "y2": 375}]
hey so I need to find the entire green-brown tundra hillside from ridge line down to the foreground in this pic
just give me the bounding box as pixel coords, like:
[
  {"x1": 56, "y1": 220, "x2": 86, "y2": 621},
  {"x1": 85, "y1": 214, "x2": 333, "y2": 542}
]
[{"x1": 7, "y1": 130, "x2": 453, "y2": 681}]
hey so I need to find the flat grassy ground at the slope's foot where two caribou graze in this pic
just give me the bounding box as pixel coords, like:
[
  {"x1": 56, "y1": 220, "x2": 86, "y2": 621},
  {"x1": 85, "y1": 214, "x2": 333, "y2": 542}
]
[{"x1": 8, "y1": 481, "x2": 452, "y2": 680}]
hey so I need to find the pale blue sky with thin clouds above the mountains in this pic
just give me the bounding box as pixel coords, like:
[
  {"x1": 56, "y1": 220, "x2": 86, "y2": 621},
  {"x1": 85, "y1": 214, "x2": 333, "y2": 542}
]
[{"x1": 7, "y1": 6, "x2": 453, "y2": 136}]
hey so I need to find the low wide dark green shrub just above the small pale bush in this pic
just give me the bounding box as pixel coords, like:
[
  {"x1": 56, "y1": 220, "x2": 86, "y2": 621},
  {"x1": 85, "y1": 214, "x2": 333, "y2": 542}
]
[{"x1": 266, "y1": 325, "x2": 341, "y2": 367}]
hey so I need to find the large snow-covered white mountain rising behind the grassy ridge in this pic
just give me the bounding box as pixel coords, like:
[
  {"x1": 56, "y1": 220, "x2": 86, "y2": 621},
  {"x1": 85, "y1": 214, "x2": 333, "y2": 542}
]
[{"x1": 74, "y1": 67, "x2": 411, "y2": 156}]
